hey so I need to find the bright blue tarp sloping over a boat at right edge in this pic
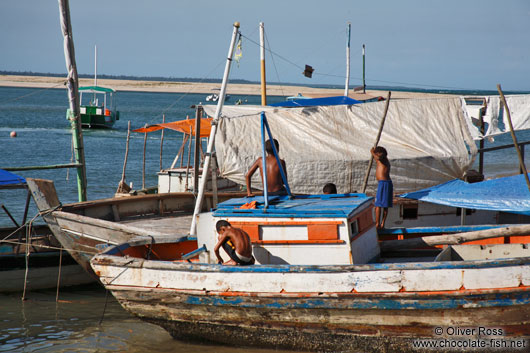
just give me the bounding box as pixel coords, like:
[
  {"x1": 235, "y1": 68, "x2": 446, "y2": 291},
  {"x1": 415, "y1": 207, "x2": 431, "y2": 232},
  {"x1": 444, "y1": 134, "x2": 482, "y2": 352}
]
[{"x1": 399, "y1": 174, "x2": 530, "y2": 215}]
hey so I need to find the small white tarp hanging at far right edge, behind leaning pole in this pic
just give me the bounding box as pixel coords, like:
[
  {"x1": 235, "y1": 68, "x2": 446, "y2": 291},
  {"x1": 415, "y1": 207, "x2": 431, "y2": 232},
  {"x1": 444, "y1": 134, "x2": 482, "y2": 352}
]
[{"x1": 462, "y1": 94, "x2": 530, "y2": 140}]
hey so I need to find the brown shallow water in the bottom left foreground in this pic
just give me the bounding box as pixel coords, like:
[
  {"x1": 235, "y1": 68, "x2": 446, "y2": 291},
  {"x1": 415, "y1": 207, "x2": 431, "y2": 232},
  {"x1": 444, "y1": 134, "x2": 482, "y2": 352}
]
[{"x1": 0, "y1": 284, "x2": 294, "y2": 353}]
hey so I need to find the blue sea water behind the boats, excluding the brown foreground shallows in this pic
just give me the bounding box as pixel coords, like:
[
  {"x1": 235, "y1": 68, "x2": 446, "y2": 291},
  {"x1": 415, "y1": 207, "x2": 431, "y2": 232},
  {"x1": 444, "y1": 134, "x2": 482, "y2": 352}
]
[{"x1": 0, "y1": 87, "x2": 285, "y2": 227}]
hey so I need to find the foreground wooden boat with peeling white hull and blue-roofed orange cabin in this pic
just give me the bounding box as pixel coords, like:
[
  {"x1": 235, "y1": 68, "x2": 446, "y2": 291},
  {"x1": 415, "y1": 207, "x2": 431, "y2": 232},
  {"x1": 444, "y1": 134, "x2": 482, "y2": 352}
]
[{"x1": 91, "y1": 194, "x2": 530, "y2": 352}]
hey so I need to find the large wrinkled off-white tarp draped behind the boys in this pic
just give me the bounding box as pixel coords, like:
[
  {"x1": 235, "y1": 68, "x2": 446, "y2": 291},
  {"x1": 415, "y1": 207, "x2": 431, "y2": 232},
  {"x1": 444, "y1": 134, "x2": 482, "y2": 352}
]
[{"x1": 204, "y1": 98, "x2": 476, "y2": 193}]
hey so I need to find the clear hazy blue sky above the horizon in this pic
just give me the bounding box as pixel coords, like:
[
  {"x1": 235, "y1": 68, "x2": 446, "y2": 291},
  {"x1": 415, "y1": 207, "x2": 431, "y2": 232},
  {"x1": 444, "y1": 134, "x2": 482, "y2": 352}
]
[{"x1": 0, "y1": 0, "x2": 530, "y2": 91}]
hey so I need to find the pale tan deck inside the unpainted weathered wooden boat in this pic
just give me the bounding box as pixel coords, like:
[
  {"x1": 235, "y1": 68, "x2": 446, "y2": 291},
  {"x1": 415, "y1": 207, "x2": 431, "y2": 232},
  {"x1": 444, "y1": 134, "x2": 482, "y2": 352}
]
[{"x1": 120, "y1": 214, "x2": 193, "y2": 235}]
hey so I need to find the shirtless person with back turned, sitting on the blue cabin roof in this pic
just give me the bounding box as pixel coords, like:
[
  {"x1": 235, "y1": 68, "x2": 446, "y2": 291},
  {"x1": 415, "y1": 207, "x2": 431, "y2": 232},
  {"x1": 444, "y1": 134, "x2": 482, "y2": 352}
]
[{"x1": 245, "y1": 139, "x2": 287, "y2": 197}]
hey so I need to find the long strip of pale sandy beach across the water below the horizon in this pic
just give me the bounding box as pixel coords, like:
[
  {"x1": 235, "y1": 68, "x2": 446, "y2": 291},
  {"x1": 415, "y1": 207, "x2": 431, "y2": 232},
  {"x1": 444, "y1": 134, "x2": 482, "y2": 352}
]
[{"x1": 0, "y1": 75, "x2": 452, "y2": 99}]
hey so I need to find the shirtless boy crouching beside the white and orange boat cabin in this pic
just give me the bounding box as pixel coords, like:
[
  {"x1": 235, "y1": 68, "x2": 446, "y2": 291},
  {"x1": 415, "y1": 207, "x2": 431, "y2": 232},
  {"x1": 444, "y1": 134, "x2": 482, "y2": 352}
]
[{"x1": 214, "y1": 220, "x2": 256, "y2": 266}]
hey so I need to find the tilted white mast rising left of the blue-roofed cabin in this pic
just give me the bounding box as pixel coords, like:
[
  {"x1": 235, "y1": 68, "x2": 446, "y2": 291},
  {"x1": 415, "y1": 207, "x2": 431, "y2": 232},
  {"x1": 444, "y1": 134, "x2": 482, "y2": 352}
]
[{"x1": 190, "y1": 22, "x2": 239, "y2": 236}]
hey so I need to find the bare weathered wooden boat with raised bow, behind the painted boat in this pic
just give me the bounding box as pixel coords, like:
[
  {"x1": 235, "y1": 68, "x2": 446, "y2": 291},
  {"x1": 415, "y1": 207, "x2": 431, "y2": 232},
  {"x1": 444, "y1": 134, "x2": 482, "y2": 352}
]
[{"x1": 27, "y1": 178, "x2": 242, "y2": 274}]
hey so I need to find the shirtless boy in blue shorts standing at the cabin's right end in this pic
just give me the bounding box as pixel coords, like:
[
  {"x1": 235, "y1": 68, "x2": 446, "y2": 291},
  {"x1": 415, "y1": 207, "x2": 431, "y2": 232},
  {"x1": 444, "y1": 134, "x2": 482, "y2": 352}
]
[{"x1": 370, "y1": 146, "x2": 394, "y2": 229}]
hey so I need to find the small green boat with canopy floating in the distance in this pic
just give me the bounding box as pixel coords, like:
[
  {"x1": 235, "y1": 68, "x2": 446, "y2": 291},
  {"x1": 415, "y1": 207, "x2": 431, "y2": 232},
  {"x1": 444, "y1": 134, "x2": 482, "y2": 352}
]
[{"x1": 66, "y1": 86, "x2": 120, "y2": 129}]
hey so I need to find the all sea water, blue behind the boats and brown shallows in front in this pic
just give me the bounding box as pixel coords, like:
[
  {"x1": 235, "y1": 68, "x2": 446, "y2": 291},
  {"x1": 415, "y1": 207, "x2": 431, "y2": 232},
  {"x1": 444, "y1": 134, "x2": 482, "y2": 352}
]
[{"x1": 0, "y1": 87, "x2": 530, "y2": 353}]
